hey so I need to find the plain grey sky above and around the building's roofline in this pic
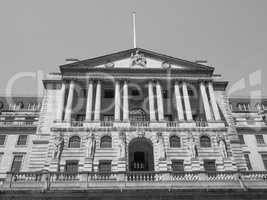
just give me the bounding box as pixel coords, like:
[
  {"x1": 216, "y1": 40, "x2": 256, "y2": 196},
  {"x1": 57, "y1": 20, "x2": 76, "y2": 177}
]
[{"x1": 0, "y1": 0, "x2": 267, "y2": 97}]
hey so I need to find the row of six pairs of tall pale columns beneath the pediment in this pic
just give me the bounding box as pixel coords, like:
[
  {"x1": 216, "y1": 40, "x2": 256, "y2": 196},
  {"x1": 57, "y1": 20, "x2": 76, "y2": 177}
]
[{"x1": 57, "y1": 80, "x2": 221, "y2": 122}]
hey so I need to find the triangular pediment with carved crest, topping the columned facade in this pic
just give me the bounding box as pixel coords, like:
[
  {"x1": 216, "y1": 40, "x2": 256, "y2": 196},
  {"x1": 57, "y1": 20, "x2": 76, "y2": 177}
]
[{"x1": 60, "y1": 48, "x2": 214, "y2": 73}]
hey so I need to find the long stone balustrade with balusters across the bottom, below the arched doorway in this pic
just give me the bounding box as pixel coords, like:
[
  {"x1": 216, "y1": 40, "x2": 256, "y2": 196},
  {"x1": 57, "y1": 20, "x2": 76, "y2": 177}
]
[{"x1": 2, "y1": 171, "x2": 267, "y2": 189}]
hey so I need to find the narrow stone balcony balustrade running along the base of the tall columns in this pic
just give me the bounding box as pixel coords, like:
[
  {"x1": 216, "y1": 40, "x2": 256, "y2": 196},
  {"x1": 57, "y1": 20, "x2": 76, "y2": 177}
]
[{"x1": 52, "y1": 121, "x2": 226, "y2": 130}]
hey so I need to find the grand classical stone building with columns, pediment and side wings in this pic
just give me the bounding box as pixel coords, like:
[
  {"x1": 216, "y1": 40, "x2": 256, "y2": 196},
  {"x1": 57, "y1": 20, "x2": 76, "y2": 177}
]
[{"x1": 0, "y1": 48, "x2": 267, "y2": 199}]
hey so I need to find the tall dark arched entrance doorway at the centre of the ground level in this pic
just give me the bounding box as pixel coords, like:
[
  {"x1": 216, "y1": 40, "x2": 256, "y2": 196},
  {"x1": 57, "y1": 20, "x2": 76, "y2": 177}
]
[{"x1": 129, "y1": 138, "x2": 154, "y2": 171}]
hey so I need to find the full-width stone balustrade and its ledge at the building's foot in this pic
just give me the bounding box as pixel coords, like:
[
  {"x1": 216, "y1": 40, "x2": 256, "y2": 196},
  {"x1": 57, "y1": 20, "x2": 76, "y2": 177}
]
[{"x1": 0, "y1": 171, "x2": 267, "y2": 191}]
